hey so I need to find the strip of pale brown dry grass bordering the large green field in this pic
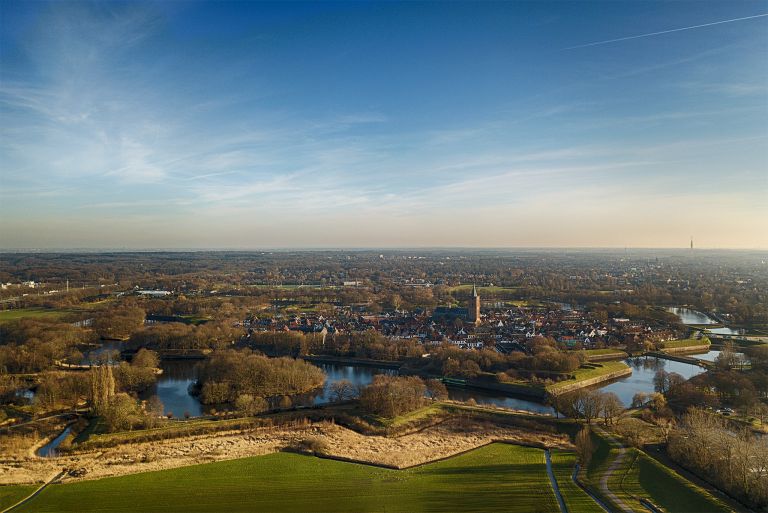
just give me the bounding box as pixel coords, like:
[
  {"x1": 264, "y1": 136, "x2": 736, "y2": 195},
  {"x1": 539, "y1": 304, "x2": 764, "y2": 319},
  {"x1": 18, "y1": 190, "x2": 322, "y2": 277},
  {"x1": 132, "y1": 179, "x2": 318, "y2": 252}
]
[{"x1": 0, "y1": 419, "x2": 571, "y2": 484}]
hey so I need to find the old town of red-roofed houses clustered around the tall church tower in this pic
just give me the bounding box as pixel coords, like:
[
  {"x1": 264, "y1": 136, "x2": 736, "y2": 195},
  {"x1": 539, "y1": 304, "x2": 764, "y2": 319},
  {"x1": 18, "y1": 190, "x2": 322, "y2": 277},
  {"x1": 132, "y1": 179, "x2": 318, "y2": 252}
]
[{"x1": 242, "y1": 288, "x2": 675, "y2": 353}]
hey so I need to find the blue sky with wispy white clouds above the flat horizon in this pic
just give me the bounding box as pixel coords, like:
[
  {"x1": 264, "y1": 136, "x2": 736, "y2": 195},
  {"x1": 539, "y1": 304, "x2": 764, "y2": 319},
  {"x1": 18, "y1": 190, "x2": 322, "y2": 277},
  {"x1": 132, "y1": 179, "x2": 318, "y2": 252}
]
[{"x1": 0, "y1": 1, "x2": 768, "y2": 249}]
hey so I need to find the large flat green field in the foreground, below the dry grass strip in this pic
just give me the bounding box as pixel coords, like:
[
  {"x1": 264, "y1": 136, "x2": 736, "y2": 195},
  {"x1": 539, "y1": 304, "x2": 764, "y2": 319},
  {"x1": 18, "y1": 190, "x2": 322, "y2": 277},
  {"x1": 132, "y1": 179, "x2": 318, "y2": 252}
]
[{"x1": 7, "y1": 444, "x2": 558, "y2": 513}]
